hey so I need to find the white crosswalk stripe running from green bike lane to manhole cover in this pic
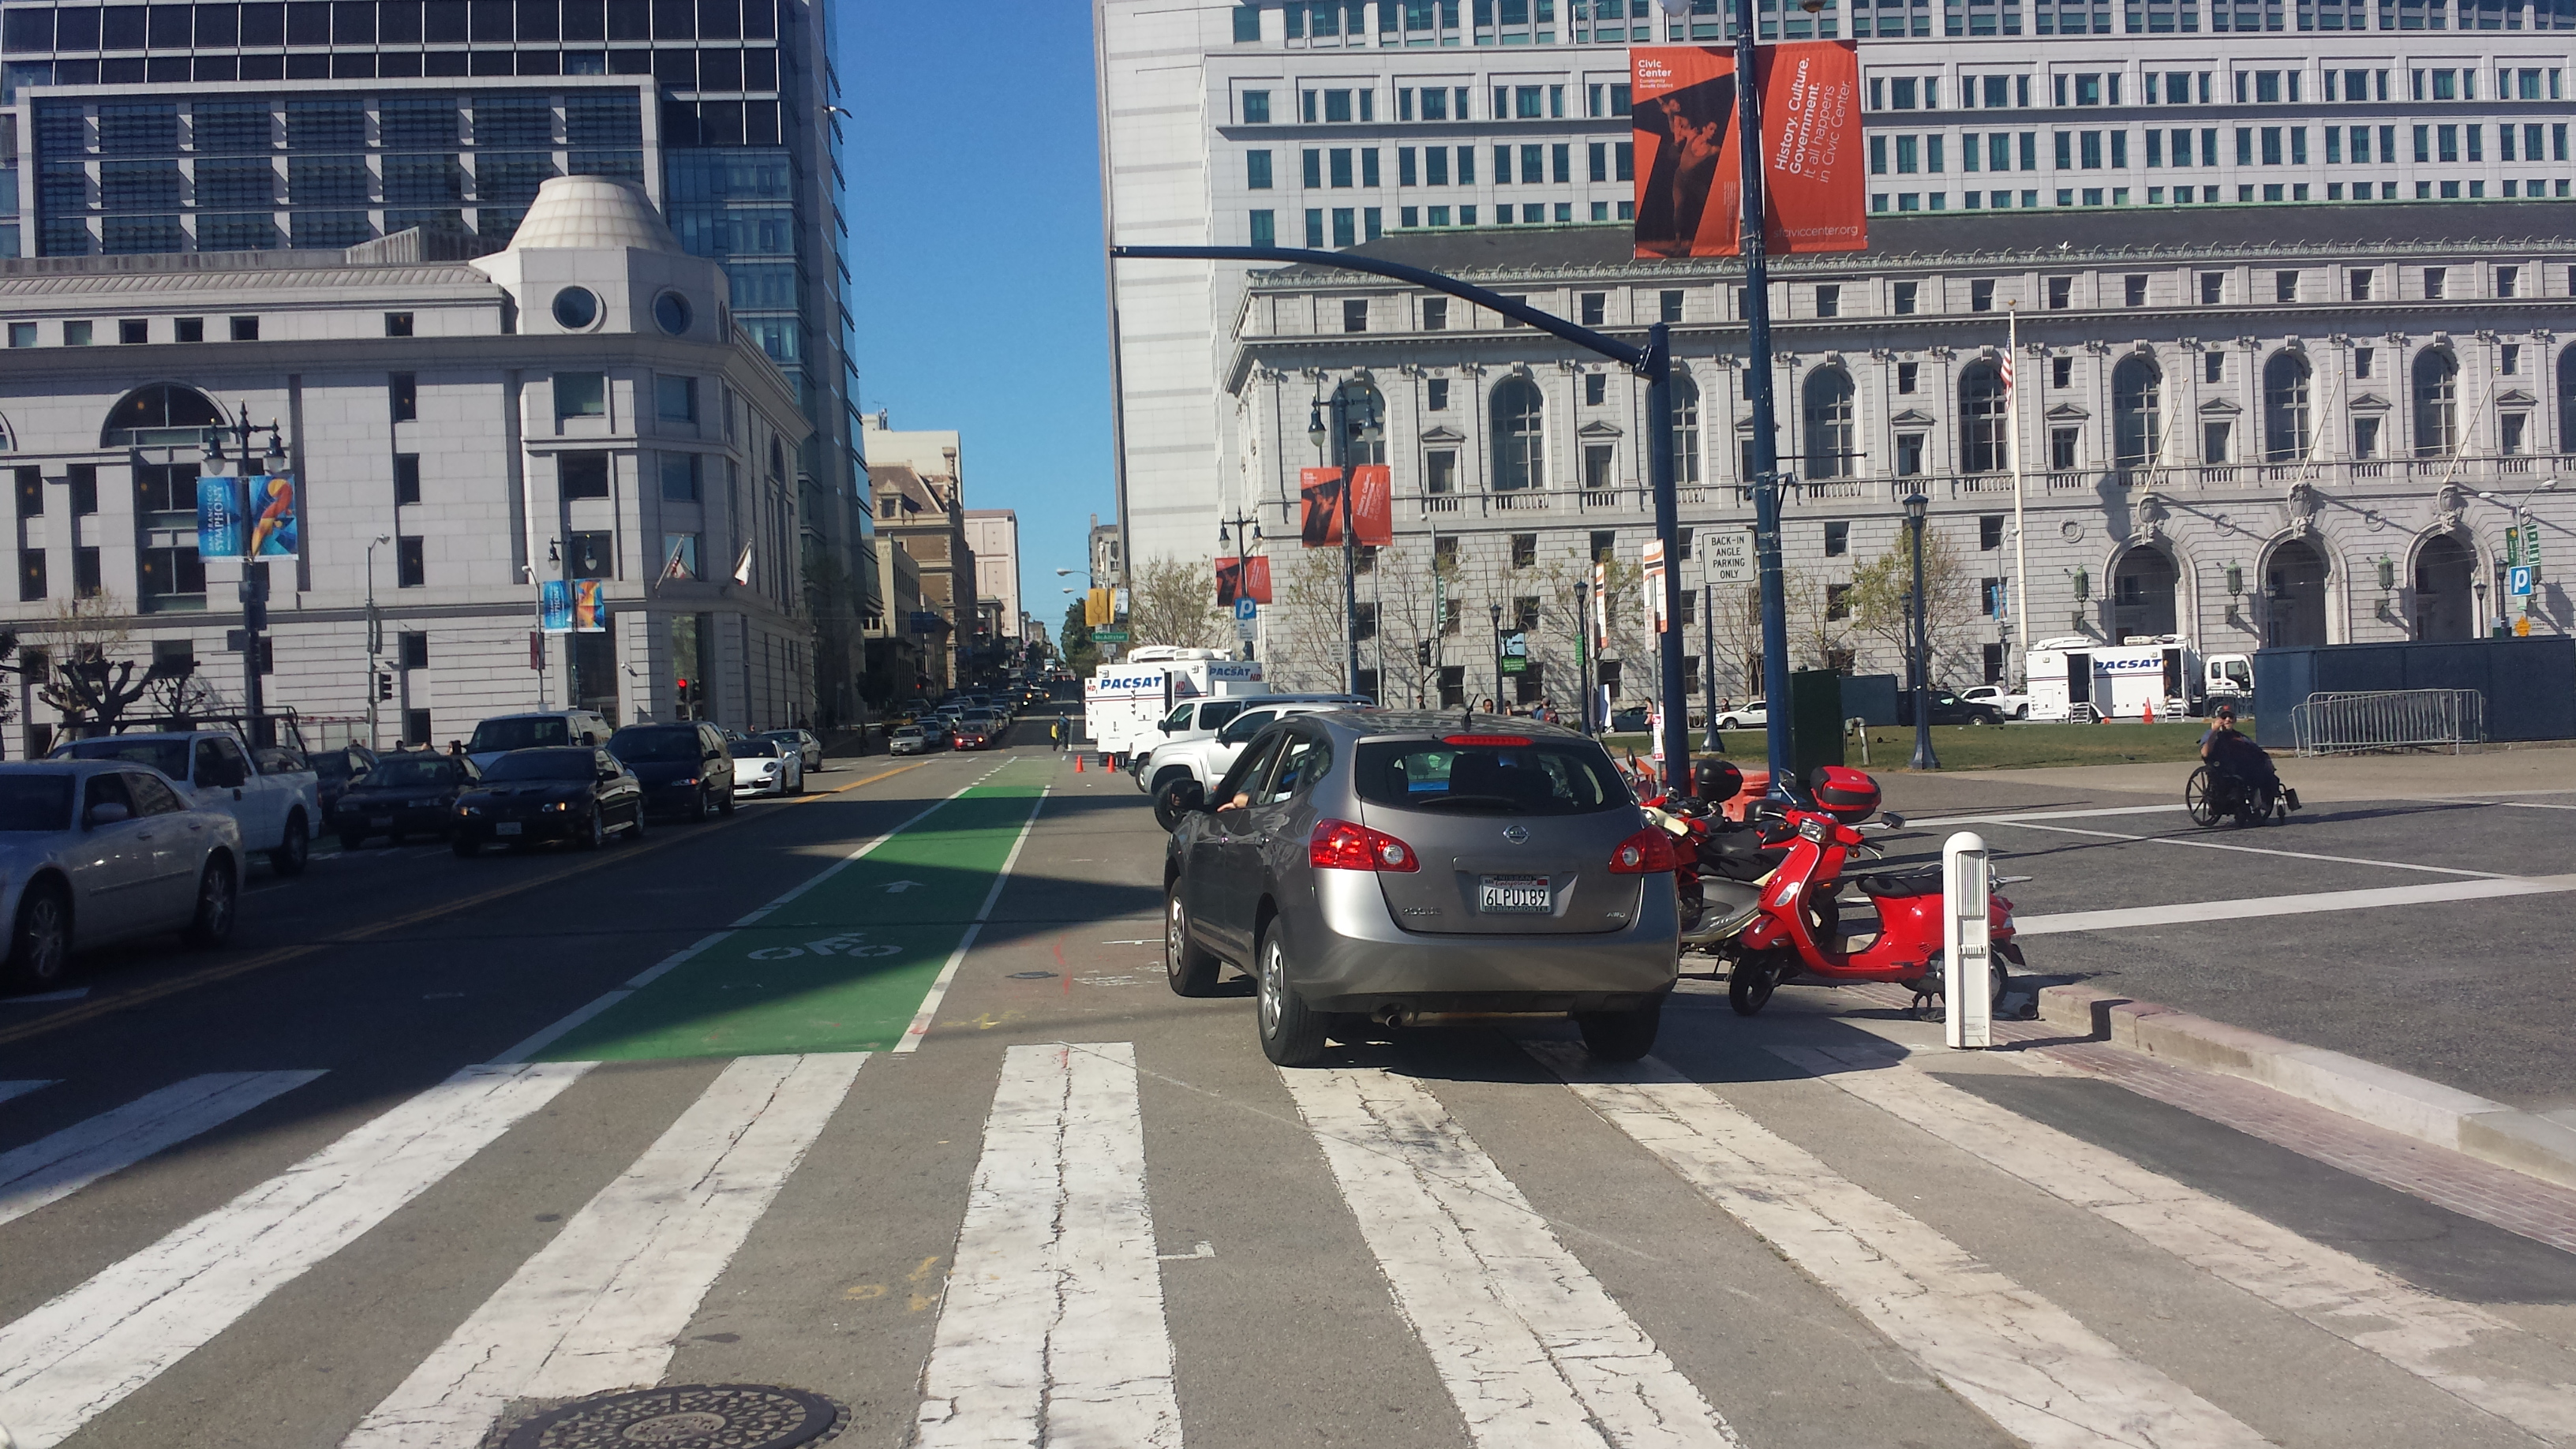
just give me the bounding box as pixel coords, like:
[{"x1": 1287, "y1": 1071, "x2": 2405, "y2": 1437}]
[{"x1": 340, "y1": 1052, "x2": 868, "y2": 1449}]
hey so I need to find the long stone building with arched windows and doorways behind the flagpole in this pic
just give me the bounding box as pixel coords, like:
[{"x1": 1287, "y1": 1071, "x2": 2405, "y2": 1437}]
[{"x1": 1219, "y1": 201, "x2": 2576, "y2": 702}]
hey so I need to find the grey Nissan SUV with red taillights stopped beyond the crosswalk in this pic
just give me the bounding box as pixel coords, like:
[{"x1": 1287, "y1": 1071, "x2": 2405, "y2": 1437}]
[{"x1": 1164, "y1": 709, "x2": 1679, "y2": 1065}]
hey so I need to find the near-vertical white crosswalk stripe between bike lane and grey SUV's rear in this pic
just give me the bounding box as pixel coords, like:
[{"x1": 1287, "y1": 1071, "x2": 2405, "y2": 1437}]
[{"x1": 912, "y1": 1042, "x2": 1180, "y2": 1449}]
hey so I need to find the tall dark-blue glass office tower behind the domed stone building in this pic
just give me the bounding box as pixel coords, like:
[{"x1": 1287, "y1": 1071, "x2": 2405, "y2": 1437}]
[{"x1": 0, "y1": 0, "x2": 881, "y2": 714}]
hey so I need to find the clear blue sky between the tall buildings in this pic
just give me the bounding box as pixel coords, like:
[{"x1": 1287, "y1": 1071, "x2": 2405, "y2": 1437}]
[{"x1": 835, "y1": 0, "x2": 1118, "y2": 637}]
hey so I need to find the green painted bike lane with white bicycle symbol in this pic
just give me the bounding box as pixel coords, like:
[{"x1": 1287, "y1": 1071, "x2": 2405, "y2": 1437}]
[{"x1": 528, "y1": 761, "x2": 1054, "y2": 1062}]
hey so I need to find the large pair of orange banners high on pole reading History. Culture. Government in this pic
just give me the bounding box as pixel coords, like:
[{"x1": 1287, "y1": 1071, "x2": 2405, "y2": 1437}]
[{"x1": 1628, "y1": 41, "x2": 1870, "y2": 258}]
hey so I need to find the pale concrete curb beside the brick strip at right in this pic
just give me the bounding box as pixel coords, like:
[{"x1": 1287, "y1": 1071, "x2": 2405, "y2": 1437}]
[{"x1": 2040, "y1": 985, "x2": 2576, "y2": 1189}]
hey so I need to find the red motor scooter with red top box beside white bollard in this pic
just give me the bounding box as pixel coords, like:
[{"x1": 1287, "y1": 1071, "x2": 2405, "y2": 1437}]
[{"x1": 1716, "y1": 766, "x2": 2030, "y2": 1016}]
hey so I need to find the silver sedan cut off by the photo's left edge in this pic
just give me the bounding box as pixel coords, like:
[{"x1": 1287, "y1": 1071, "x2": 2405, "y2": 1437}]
[{"x1": 0, "y1": 761, "x2": 242, "y2": 990}]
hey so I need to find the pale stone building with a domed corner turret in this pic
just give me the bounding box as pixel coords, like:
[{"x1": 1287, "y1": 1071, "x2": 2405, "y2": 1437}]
[{"x1": 0, "y1": 178, "x2": 819, "y2": 755}]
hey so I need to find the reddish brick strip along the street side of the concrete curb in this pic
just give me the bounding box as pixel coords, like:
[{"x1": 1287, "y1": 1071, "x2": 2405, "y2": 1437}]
[{"x1": 1842, "y1": 985, "x2": 2576, "y2": 1253}]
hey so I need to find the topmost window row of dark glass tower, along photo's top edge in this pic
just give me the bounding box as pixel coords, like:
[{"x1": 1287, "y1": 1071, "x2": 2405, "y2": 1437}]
[{"x1": 0, "y1": 0, "x2": 778, "y2": 54}]
